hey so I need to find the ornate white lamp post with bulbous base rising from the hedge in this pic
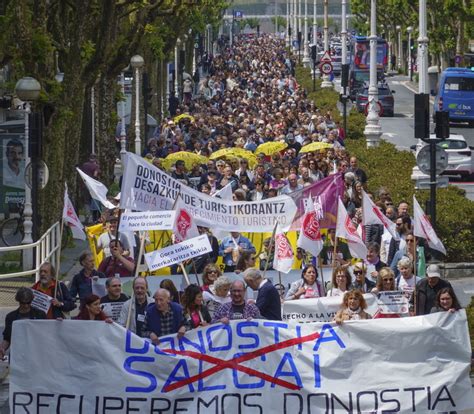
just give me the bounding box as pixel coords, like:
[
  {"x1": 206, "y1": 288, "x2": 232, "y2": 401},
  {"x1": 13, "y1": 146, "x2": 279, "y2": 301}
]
[{"x1": 364, "y1": 0, "x2": 382, "y2": 147}]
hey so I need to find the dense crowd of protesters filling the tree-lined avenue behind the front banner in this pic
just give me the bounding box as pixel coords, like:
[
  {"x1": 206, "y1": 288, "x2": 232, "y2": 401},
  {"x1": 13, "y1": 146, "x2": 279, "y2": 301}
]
[{"x1": 0, "y1": 35, "x2": 459, "y2": 354}]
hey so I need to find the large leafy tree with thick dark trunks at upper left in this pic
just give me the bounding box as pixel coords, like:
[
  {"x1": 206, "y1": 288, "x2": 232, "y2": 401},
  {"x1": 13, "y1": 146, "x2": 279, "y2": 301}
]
[{"x1": 0, "y1": 0, "x2": 227, "y2": 231}]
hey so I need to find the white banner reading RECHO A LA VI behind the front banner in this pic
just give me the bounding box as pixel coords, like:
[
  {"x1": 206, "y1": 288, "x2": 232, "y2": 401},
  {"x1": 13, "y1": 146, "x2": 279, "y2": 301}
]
[{"x1": 281, "y1": 293, "x2": 378, "y2": 323}]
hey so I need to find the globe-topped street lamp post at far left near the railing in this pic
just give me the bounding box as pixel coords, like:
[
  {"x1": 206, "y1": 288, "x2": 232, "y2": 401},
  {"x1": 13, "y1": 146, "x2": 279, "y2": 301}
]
[{"x1": 15, "y1": 76, "x2": 41, "y2": 270}]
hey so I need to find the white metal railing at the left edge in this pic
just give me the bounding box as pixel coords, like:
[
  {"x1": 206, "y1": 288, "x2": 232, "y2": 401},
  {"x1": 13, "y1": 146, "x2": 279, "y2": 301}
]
[{"x1": 0, "y1": 222, "x2": 61, "y2": 280}]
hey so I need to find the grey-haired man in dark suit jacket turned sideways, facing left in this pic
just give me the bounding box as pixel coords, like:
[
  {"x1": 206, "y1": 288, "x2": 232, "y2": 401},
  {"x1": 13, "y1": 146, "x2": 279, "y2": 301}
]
[{"x1": 243, "y1": 268, "x2": 281, "y2": 321}]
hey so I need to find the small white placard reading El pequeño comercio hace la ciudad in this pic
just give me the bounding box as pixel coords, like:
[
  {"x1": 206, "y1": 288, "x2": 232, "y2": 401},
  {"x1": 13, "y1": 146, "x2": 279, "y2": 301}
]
[{"x1": 119, "y1": 210, "x2": 176, "y2": 233}]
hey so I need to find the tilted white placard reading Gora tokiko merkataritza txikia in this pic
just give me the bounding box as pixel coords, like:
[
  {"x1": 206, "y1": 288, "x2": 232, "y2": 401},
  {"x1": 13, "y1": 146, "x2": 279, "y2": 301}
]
[{"x1": 145, "y1": 234, "x2": 212, "y2": 272}]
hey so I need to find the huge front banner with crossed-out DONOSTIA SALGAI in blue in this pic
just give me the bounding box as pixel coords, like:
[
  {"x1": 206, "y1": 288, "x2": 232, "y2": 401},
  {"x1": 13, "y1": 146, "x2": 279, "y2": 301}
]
[{"x1": 9, "y1": 310, "x2": 474, "y2": 414}]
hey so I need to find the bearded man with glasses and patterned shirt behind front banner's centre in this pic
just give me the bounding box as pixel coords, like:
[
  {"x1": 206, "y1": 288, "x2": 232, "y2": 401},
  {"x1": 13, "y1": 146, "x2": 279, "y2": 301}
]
[{"x1": 211, "y1": 280, "x2": 262, "y2": 324}]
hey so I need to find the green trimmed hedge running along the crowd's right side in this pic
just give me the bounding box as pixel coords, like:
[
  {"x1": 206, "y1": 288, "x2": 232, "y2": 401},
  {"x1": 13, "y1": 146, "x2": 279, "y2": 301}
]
[{"x1": 296, "y1": 67, "x2": 474, "y2": 262}]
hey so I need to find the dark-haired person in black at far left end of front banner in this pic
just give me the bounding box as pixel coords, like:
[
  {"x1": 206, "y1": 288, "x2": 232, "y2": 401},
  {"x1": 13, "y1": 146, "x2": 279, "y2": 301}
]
[{"x1": 0, "y1": 287, "x2": 47, "y2": 359}]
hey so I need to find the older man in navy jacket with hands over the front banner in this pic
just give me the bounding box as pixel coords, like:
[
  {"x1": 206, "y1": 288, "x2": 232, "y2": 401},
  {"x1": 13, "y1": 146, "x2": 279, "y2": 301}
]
[{"x1": 143, "y1": 288, "x2": 186, "y2": 345}]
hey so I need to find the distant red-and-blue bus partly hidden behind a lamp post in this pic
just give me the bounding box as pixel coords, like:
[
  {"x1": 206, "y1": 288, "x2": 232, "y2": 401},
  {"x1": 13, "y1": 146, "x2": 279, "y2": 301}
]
[{"x1": 349, "y1": 36, "x2": 388, "y2": 100}]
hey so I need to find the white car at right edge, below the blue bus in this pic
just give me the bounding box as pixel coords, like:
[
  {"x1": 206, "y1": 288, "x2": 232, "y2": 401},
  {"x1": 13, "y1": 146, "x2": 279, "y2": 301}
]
[{"x1": 410, "y1": 134, "x2": 474, "y2": 179}]
